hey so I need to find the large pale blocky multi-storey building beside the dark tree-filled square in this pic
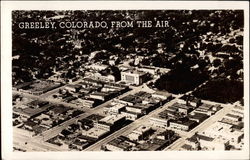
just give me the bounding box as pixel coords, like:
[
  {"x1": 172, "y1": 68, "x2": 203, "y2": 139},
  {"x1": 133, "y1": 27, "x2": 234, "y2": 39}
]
[{"x1": 121, "y1": 70, "x2": 147, "y2": 85}]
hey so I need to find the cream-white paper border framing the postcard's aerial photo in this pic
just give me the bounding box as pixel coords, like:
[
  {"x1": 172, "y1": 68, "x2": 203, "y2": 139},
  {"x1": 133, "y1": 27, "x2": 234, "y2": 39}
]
[{"x1": 1, "y1": 1, "x2": 249, "y2": 160}]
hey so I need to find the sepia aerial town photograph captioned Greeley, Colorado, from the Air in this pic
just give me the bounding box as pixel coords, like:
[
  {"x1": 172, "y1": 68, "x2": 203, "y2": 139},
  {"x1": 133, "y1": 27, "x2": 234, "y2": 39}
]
[{"x1": 12, "y1": 10, "x2": 244, "y2": 152}]
